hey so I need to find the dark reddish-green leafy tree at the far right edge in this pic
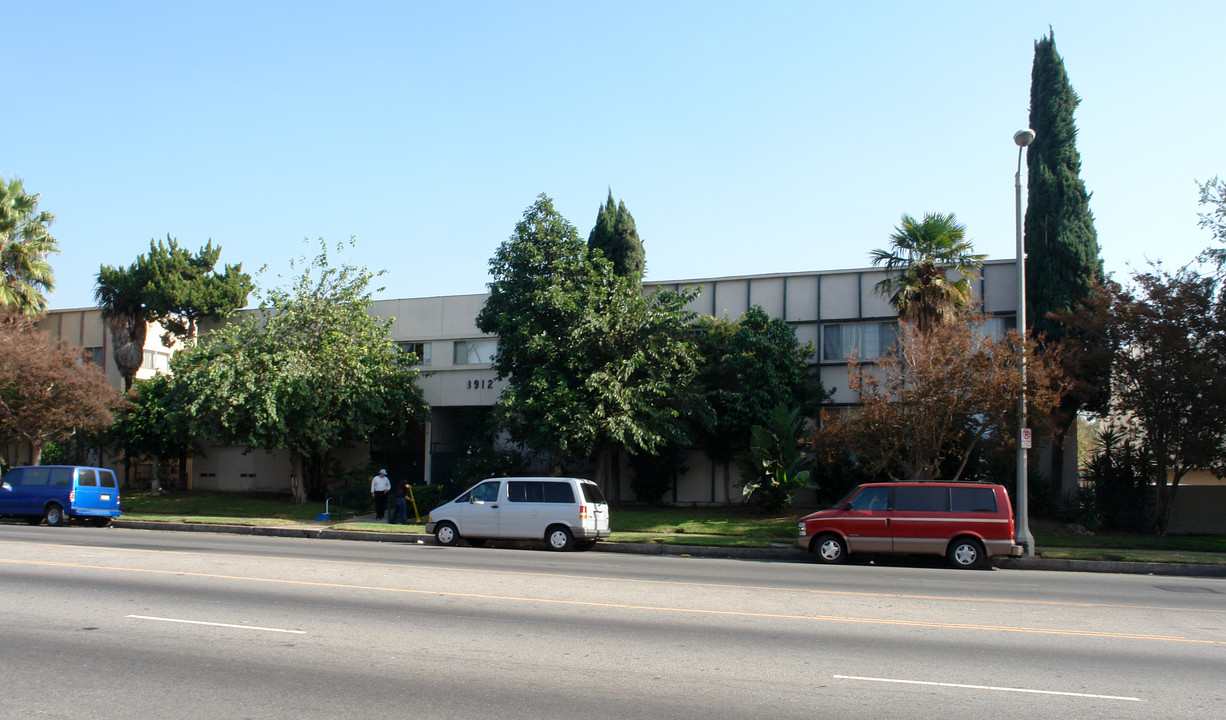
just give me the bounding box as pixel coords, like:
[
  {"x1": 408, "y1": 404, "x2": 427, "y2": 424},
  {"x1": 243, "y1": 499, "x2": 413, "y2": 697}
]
[{"x1": 1111, "y1": 267, "x2": 1226, "y2": 534}]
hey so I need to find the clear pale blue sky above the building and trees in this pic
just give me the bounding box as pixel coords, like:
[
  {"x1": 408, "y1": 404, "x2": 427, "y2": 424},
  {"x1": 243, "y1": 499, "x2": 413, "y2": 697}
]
[{"x1": 9, "y1": 0, "x2": 1226, "y2": 308}]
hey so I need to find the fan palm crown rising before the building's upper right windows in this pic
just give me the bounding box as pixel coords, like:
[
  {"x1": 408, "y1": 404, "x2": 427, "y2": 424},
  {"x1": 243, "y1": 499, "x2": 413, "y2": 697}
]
[{"x1": 870, "y1": 212, "x2": 986, "y2": 332}]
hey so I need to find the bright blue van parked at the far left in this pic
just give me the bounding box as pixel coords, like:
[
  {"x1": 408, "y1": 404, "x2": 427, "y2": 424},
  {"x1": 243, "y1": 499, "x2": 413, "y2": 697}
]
[{"x1": 0, "y1": 465, "x2": 119, "y2": 527}]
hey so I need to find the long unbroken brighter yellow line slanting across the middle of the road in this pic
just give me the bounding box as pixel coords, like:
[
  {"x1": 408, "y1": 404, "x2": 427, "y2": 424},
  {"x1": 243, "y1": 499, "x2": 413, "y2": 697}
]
[{"x1": 0, "y1": 558, "x2": 1226, "y2": 645}]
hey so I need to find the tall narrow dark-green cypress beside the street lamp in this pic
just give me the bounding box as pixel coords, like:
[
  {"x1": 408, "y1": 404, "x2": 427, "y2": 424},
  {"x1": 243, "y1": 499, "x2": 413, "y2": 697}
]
[{"x1": 1025, "y1": 33, "x2": 1111, "y2": 499}]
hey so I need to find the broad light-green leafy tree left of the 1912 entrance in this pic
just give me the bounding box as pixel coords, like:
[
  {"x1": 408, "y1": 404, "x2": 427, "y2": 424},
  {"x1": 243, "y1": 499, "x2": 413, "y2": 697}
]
[{"x1": 170, "y1": 240, "x2": 425, "y2": 502}]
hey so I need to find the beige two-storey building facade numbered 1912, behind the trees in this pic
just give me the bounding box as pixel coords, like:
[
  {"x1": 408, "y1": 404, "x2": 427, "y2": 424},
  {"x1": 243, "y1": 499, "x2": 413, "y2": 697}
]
[{"x1": 31, "y1": 260, "x2": 1018, "y2": 504}]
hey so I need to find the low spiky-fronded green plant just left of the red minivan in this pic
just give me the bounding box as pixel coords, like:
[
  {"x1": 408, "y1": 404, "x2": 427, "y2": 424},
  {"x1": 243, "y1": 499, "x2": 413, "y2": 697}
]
[{"x1": 737, "y1": 402, "x2": 810, "y2": 513}]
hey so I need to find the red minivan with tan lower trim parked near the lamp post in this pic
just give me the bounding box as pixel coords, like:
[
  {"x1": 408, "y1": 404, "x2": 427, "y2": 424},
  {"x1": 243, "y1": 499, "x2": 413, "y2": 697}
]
[{"x1": 797, "y1": 482, "x2": 1022, "y2": 568}]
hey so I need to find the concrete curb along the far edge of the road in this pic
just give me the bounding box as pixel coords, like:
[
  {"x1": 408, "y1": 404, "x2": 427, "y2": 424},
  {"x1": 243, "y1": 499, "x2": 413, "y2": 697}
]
[{"x1": 112, "y1": 519, "x2": 1226, "y2": 578}]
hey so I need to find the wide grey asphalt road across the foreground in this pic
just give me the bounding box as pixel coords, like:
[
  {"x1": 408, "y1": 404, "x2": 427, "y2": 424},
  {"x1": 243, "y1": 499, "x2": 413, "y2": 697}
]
[{"x1": 0, "y1": 524, "x2": 1226, "y2": 720}]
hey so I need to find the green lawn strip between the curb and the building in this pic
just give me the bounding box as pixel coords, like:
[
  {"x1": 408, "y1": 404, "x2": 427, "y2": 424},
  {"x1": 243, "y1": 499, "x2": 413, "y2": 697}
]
[{"x1": 123, "y1": 491, "x2": 1226, "y2": 564}]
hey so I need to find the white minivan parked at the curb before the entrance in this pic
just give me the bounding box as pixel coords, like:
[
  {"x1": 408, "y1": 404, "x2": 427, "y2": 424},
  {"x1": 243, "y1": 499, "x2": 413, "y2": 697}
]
[{"x1": 425, "y1": 477, "x2": 609, "y2": 550}]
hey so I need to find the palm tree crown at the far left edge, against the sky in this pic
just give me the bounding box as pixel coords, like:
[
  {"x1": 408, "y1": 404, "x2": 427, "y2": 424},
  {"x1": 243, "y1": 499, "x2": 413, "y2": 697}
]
[{"x1": 0, "y1": 177, "x2": 59, "y2": 315}]
